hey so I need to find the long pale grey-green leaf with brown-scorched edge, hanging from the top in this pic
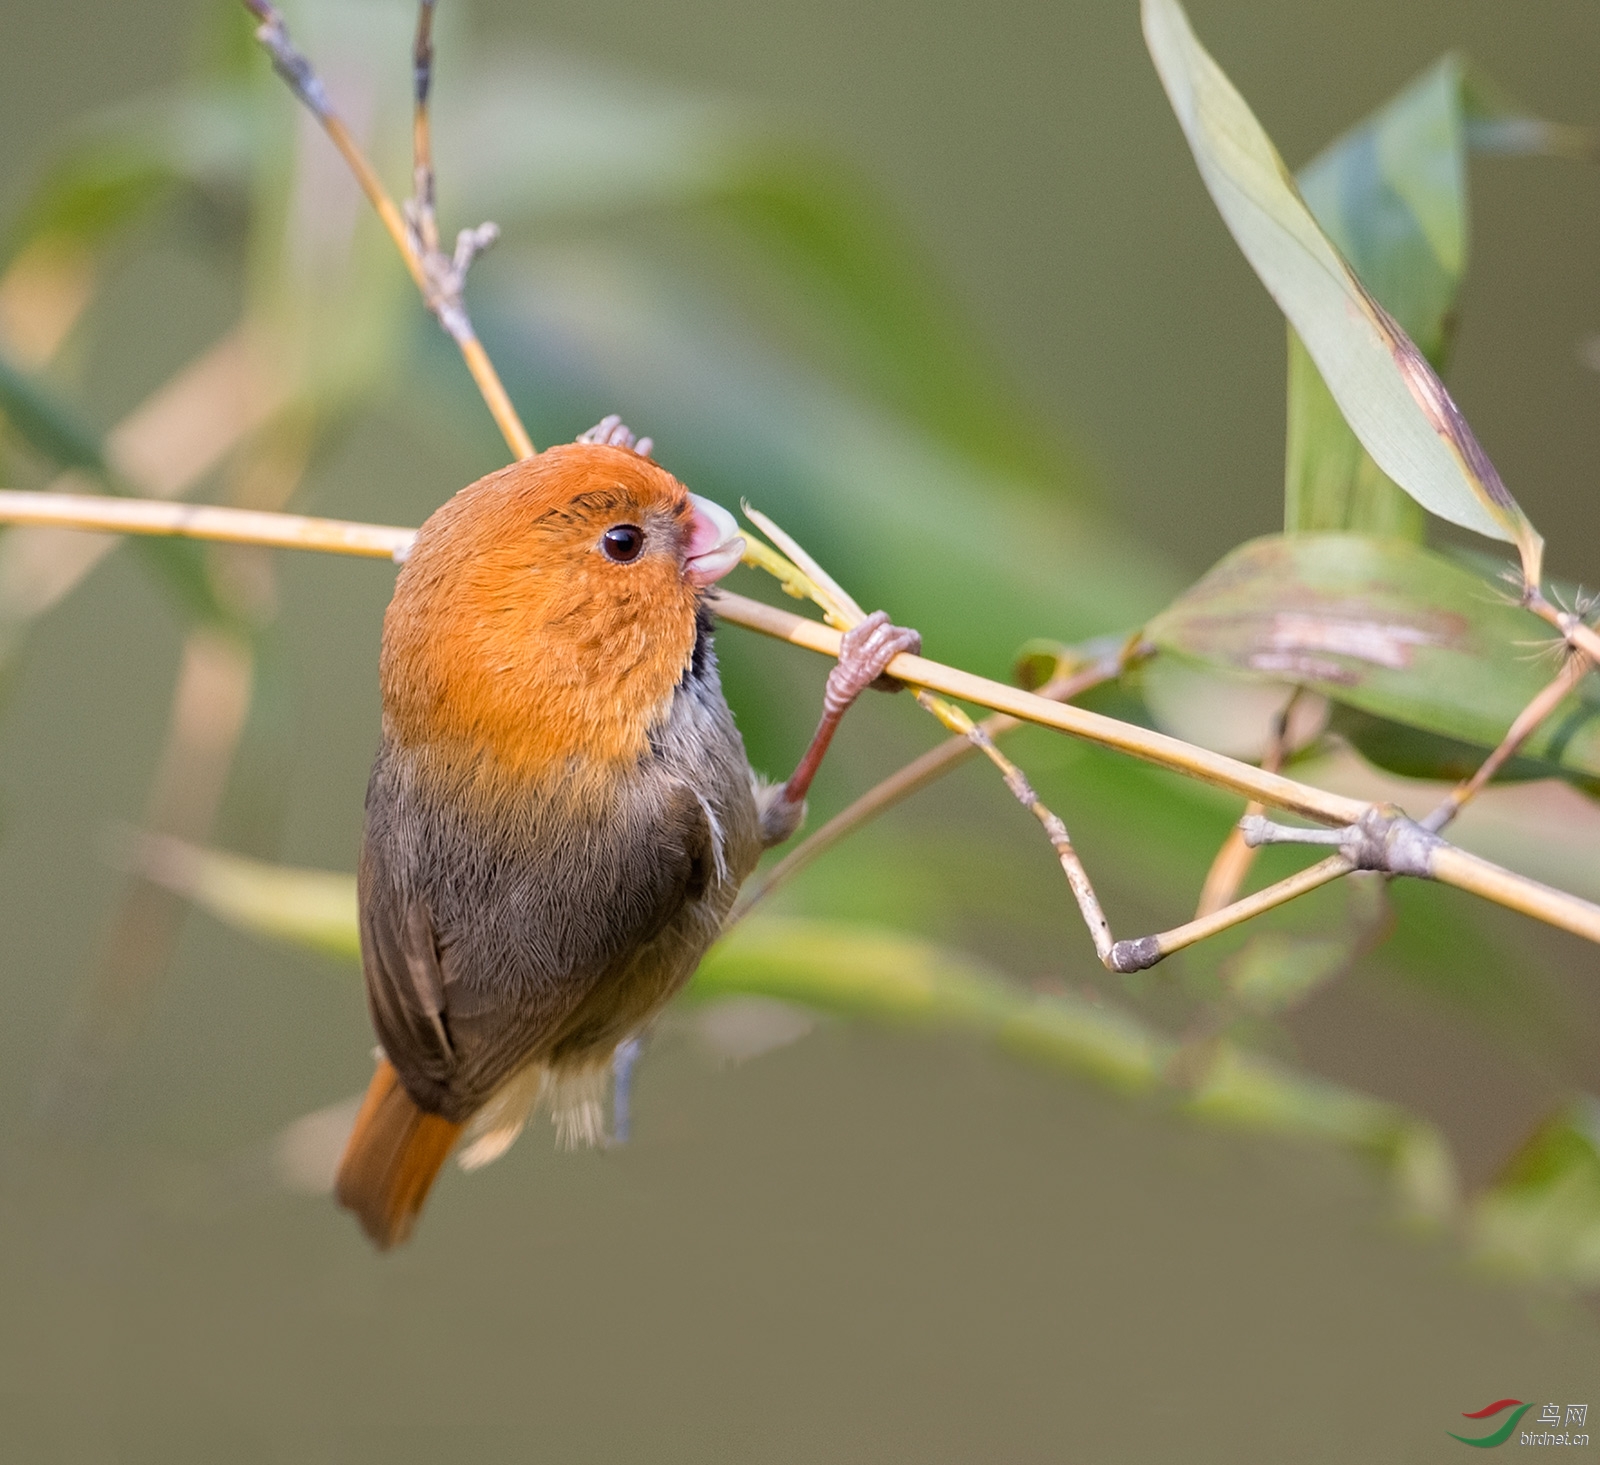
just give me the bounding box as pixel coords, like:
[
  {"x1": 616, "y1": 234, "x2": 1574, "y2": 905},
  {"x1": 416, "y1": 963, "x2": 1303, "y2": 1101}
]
[{"x1": 1142, "y1": 0, "x2": 1544, "y2": 584}]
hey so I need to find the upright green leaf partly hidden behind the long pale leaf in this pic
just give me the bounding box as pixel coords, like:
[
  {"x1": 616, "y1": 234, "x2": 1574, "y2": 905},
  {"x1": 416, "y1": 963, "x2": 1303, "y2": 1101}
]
[{"x1": 1283, "y1": 56, "x2": 1594, "y2": 541}]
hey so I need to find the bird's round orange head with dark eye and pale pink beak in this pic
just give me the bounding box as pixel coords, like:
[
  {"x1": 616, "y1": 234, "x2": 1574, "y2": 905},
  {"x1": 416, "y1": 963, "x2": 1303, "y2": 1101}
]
[{"x1": 381, "y1": 443, "x2": 742, "y2": 792}]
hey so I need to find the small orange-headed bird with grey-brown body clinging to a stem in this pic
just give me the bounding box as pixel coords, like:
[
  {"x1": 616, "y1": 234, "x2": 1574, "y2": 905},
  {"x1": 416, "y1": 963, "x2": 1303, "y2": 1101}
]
[{"x1": 336, "y1": 417, "x2": 922, "y2": 1247}]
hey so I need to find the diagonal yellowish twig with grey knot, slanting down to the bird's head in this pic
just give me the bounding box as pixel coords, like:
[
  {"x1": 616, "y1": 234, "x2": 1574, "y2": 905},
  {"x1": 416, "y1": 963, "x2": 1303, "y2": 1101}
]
[{"x1": 243, "y1": 0, "x2": 534, "y2": 457}]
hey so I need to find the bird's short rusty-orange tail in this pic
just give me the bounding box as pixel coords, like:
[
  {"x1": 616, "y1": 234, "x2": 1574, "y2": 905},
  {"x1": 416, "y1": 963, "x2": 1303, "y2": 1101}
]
[{"x1": 334, "y1": 1059, "x2": 461, "y2": 1251}]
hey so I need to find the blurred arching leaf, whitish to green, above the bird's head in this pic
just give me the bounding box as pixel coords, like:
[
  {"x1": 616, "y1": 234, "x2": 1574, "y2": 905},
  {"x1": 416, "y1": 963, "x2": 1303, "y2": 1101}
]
[{"x1": 435, "y1": 54, "x2": 1062, "y2": 478}]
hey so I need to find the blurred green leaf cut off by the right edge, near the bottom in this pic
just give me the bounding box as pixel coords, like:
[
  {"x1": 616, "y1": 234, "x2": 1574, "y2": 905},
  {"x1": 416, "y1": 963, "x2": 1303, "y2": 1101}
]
[{"x1": 1472, "y1": 1094, "x2": 1600, "y2": 1287}]
